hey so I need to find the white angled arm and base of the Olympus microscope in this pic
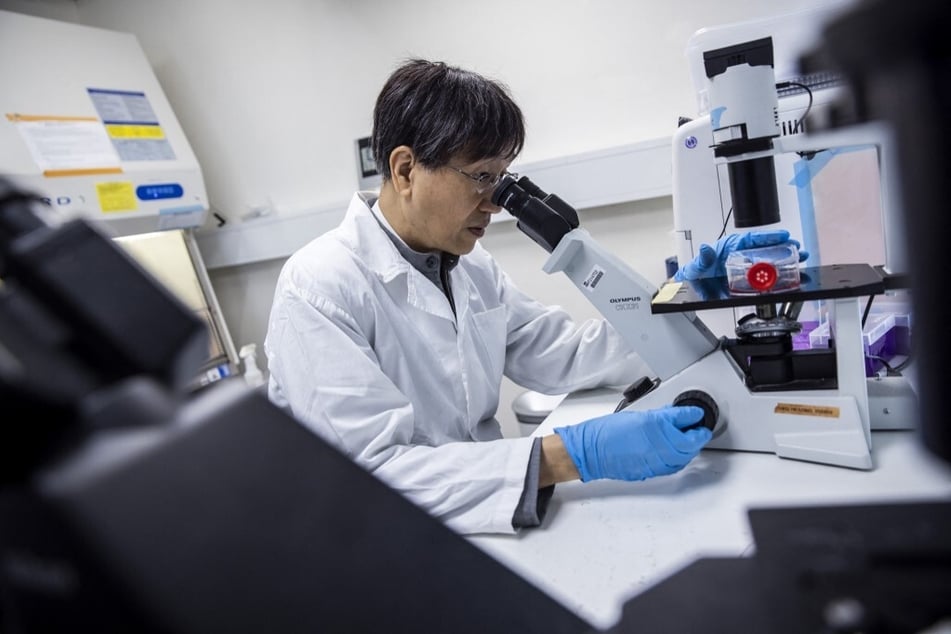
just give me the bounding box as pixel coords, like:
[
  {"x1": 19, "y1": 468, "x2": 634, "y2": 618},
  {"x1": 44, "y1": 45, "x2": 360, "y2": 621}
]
[{"x1": 520, "y1": 212, "x2": 872, "y2": 469}]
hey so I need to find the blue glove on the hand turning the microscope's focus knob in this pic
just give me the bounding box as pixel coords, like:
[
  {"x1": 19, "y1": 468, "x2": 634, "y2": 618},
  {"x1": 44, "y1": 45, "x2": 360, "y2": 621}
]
[{"x1": 555, "y1": 405, "x2": 713, "y2": 482}]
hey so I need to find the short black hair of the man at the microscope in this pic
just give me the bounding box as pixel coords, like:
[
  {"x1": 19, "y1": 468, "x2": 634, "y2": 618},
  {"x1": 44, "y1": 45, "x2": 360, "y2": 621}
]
[{"x1": 372, "y1": 59, "x2": 525, "y2": 180}]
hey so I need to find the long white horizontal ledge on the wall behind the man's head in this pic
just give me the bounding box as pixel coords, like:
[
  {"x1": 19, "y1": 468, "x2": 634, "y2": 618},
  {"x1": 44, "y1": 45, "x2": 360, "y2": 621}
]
[{"x1": 195, "y1": 137, "x2": 671, "y2": 269}]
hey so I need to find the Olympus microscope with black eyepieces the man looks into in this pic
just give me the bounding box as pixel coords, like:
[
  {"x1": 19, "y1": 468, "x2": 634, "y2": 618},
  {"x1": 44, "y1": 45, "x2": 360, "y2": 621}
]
[{"x1": 492, "y1": 37, "x2": 899, "y2": 469}]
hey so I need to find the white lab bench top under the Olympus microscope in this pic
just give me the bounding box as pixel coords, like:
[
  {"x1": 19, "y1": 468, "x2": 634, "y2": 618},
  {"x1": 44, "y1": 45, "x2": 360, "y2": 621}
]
[{"x1": 470, "y1": 390, "x2": 951, "y2": 628}]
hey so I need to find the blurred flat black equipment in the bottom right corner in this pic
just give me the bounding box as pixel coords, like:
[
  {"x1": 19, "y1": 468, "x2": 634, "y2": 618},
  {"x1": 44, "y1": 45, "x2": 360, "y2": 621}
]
[{"x1": 609, "y1": 502, "x2": 951, "y2": 634}]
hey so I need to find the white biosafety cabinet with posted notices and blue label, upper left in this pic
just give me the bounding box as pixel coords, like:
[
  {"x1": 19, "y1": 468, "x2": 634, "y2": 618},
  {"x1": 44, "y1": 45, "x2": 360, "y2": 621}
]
[{"x1": 0, "y1": 11, "x2": 238, "y2": 383}]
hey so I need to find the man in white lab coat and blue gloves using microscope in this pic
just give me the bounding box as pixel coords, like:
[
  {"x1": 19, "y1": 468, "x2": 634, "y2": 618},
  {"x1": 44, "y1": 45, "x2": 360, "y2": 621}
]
[{"x1": 265, "y1": 60, "x2": 804, "y2": 533}]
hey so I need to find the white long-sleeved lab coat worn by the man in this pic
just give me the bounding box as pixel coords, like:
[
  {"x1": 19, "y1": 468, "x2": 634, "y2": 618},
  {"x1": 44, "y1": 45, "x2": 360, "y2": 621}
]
[{"x1": 265, "y1": 193, "x2": 646, "y2": 533}]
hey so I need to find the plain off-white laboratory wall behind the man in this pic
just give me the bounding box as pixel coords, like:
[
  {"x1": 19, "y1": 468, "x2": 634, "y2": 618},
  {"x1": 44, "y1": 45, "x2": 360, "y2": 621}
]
[{"x1": 7, "y1": 0, "x2": 840, "y2": 429}]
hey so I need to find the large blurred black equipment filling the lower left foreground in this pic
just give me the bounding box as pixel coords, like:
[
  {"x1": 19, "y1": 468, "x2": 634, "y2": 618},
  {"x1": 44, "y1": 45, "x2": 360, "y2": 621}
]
[{"x1": 0, "y1": 185, "x2": 590, "y2": 634}]
